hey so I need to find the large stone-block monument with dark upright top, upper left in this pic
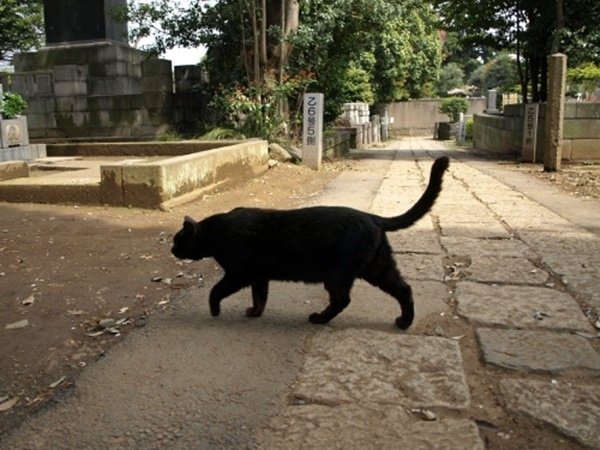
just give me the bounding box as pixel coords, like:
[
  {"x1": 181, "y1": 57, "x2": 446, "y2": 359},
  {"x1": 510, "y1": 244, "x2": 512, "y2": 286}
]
[{"x1": 0, "y1": 0, "x2": 185, "y2": 141}]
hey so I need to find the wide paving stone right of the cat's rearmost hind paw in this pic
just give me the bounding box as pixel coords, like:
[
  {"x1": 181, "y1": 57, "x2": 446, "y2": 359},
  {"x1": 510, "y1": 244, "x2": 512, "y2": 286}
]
[{"x1": 455, "y1": 282, "x2": 594, "y2": 333}]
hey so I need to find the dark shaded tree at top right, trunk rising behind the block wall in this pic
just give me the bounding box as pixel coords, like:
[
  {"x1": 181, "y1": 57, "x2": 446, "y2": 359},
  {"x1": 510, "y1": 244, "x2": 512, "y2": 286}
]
[{"x1": 434, "y1": 0, "x2": 600, "y2": 101}]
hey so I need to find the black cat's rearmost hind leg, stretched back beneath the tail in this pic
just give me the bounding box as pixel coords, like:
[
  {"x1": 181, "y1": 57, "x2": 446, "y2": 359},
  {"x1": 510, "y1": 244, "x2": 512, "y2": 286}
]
[{"x1": 362, "y1": 255, "x2": 415, "y2": 330}]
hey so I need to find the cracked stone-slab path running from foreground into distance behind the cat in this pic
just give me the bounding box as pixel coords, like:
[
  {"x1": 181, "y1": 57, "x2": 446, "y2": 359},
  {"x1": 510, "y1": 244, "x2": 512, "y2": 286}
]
[{"x1": 259, "y1": 139, "x2": 600, "y2": 449}]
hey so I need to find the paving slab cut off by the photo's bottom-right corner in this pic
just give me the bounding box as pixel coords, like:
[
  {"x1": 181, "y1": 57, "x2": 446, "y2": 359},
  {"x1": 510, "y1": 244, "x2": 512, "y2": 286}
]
[{"x1": 500, "y1": 380, "x2": 600, "y2": 448}]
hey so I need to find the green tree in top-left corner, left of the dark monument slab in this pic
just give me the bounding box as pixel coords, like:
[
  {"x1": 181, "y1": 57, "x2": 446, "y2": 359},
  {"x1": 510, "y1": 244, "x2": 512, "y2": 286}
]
[{"x1": 0, "y1": 0, "x2": 43, "y2": 62}]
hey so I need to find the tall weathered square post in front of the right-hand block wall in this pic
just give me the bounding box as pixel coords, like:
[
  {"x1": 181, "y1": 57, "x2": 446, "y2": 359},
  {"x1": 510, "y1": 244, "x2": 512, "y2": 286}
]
[{"x1": 544, "y1": 53, "x2": 567, "y2": 172}]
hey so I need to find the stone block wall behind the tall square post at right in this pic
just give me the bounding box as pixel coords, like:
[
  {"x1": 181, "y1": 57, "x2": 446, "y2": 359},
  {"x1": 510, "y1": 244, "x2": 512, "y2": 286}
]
[{"x1": 473, "y1": 102, "x2": 600, "y2": 162}]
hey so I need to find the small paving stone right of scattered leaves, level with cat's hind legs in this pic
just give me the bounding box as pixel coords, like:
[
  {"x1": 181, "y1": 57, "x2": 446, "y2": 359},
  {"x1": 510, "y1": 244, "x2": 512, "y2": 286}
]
[{"x1": 466, "y1": 256, "x2": 548, "y2": 284}]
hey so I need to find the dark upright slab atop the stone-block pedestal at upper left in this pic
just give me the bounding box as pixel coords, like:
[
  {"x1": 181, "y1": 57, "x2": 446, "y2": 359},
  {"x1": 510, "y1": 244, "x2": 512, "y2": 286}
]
[{"x1": 44, "y1": 0, "x2": 127, "y2": 46}]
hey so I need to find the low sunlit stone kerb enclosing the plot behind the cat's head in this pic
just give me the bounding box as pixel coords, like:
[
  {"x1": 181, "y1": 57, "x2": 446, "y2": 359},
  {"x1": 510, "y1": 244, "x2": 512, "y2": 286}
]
[{"x1": 0, "y1": 139, "x2": 269, "y2": 209}]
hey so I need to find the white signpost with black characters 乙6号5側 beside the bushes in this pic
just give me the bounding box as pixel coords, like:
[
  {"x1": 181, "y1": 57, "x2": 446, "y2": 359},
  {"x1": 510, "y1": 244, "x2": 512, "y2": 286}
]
[{"x1": 302, "y1": 93, "x2": 323, "y2": 170}]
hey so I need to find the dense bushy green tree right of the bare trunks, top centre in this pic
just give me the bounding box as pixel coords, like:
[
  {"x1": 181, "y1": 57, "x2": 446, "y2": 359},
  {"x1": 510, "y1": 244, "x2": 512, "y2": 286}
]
[{"x1": 290, "y1": 0, "x2": 441, "y2": 120}]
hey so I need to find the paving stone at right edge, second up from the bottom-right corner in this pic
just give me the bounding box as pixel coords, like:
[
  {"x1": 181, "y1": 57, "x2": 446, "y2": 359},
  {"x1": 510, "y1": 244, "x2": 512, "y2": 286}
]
[{"x1": 477, "y1": 328, "x2": 600, "y2": 374}]
